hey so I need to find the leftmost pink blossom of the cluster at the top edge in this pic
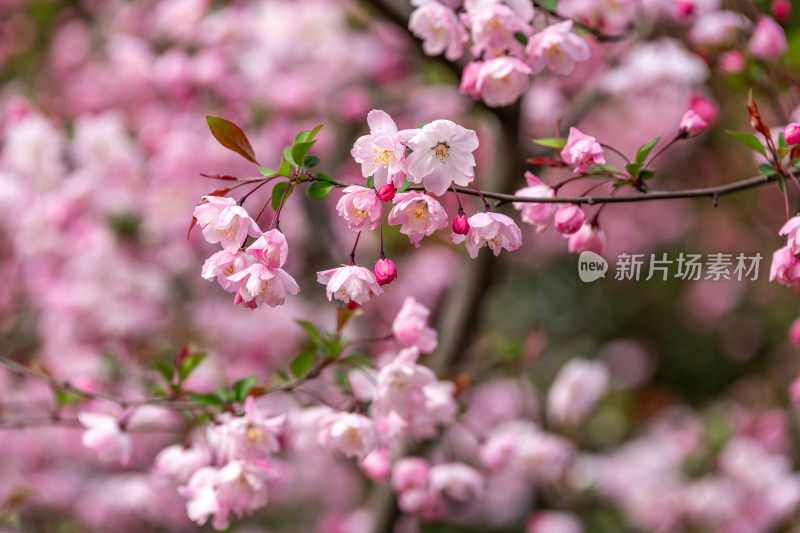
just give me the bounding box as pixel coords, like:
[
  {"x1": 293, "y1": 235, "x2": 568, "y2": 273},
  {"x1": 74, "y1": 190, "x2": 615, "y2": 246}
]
[{"x1": 408, "y1": 0, "x2": 469, "y2": 61}]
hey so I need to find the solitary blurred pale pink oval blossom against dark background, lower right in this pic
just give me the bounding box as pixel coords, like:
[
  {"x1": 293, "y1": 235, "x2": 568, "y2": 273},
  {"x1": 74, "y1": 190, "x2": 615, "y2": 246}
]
[{"x1": 547, "y1": 358, "x2": 609, "y2": 424}]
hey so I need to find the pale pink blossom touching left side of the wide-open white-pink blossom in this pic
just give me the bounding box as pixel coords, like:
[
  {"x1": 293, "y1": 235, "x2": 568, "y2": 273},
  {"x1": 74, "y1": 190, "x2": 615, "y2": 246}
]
[{"x1": 354, "y1": 109, "x2": 406, "y2": 188}]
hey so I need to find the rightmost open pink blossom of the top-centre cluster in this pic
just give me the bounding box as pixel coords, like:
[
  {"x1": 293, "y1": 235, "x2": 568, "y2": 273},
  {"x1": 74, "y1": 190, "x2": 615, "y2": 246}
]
[{"x1": 525, "y1": 20, "x2": 591, "y2": 76}]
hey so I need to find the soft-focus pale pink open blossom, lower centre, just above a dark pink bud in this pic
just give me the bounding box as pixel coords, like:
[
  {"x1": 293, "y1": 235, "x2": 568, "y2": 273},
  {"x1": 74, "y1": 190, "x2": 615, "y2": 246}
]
[{"x1": 318, "y1": 412, "x2": 378, "y2": 458}]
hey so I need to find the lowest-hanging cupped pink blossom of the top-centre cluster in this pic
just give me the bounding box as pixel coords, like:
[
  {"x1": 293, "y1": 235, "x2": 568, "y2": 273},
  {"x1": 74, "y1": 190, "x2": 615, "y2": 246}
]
[{"x1": 475, "y1": 56, "x2": 532, "y2": 107}]
